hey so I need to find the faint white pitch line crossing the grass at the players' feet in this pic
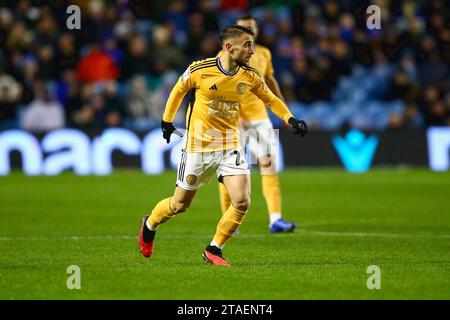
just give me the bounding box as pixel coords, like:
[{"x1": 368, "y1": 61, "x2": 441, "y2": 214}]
[{"x1": 0, "y1": 229, "x2": 450, "y2": 241}]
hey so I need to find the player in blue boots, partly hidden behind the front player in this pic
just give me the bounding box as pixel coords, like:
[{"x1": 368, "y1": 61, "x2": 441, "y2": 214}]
[{"x1": 219, "y1": 15, "x2": 296, "y2": 233}]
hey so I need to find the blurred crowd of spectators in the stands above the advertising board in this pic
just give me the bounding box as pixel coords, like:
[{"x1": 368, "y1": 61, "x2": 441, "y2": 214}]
[{"x1": 0, "y1": 0, "x2": 450, "y2": 132}]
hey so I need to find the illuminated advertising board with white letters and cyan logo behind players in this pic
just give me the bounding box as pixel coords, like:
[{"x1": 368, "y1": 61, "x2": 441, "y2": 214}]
[{"x1": 0, "y1": 127, "x2": 450, "y2": 175}]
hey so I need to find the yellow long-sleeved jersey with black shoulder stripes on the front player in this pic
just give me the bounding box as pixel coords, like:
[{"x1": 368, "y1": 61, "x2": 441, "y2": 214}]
[{"x1": 163, "y1": 57, "x2": 292, "y2": 152}]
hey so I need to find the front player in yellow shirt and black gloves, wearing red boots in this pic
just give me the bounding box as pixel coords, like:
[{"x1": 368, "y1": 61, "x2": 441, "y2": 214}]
[{"x1": 139, "y1": 26, "x2": 307, "y2": 266}]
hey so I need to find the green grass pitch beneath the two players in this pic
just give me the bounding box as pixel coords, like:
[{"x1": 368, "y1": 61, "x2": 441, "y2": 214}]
[{"x1": 0, "y1": 169, "x2": 450, "y2": 300}]
